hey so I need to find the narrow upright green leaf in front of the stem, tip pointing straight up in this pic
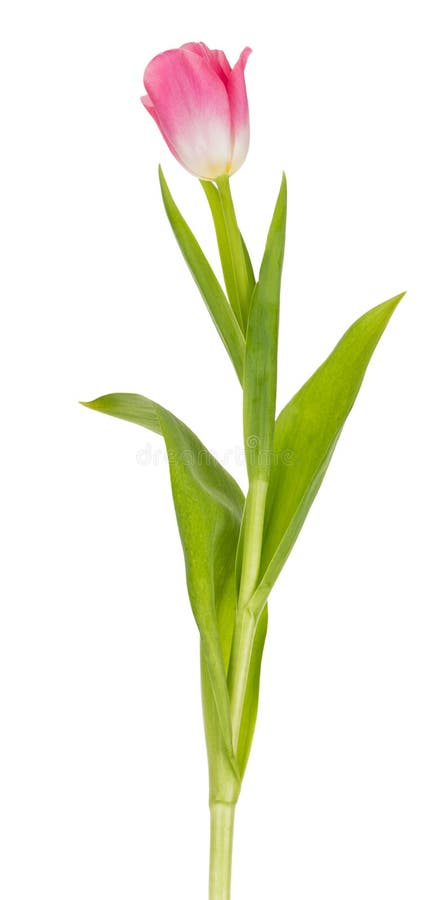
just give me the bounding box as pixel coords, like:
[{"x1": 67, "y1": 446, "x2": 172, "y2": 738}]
[{"x1": 243, "y1": 175, "x2": 287, "y2": 482}]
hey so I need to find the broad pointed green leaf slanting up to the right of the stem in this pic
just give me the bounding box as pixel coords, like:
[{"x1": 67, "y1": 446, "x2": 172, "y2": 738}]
[{"x1": 251, "y1": 294, "x2": 404, "y2": 612}]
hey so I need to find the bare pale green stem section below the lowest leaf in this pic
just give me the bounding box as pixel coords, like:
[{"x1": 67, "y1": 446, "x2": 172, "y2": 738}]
[{"x1": 209, "y1": 803, "x2": 235, "y2": 900}]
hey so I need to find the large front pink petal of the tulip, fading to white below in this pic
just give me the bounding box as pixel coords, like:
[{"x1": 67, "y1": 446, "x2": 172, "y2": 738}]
[{"x1": 144, "y1": 44, "x2": 232, "y2": 178}]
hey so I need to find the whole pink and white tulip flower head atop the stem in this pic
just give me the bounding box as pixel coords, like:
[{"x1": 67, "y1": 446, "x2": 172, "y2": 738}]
[{"x1": 141, "y1": 43, "x2": 251, "y2": 180}]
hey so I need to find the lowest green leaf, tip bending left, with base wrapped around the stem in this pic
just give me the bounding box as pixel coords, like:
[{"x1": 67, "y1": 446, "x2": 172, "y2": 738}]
[{"x1": 83, "y1": 394, "x2": 267, "y2": 802}]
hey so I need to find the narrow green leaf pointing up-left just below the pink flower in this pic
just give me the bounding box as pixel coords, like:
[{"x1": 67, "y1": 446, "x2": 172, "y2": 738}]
[{"x1": 159, "y1": 167, "x2": 245, "y2": 382}]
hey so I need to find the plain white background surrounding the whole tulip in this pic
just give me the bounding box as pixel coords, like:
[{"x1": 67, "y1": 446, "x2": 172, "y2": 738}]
[{"x1": 0, "y1": 0, "x2": 438, "y2": 900}]
